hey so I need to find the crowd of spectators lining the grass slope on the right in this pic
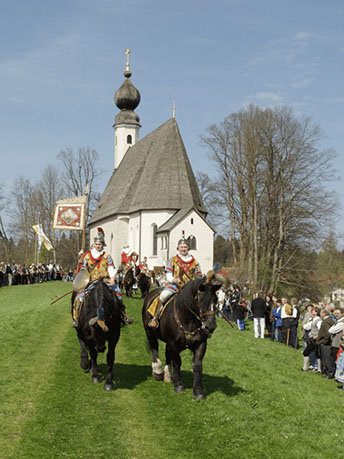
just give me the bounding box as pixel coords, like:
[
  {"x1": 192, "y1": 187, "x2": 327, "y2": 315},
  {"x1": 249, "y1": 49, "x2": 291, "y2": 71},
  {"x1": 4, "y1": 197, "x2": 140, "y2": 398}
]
[{"x1": 217, "y1": 285, "x2": 344, "y2": 390}]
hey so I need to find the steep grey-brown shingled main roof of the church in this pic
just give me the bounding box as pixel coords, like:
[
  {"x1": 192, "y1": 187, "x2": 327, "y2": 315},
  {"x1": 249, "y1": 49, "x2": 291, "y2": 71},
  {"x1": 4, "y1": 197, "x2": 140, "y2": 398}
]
[{"x1": 90, "y1": 118, "x2": 207, "y2": 224}]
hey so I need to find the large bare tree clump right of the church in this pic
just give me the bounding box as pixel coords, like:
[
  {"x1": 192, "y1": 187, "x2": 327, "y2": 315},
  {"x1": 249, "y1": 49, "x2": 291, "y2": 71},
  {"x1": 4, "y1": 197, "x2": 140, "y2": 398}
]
[{"x1": 201, "y1": 105, "x2": 335, "y2": 291}]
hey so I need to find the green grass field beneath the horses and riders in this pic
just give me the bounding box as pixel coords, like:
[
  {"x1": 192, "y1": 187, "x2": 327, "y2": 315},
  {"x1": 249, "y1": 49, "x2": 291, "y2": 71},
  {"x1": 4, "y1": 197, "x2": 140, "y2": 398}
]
[{"x1": 0, "y1": 282, "x2": 344, "y2": 458}]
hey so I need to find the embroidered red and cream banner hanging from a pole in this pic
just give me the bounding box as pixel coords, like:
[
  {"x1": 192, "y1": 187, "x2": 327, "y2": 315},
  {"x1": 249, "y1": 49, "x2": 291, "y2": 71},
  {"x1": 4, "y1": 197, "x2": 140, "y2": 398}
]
[{"x1": 53, "y1": 196, "x2": 86, "y2": 231}]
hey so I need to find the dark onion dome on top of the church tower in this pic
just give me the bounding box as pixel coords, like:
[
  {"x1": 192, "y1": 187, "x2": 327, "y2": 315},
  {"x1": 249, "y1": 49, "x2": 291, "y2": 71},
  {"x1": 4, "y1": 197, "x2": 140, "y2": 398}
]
[{"x1": 115, "y1": 66, "x2": 141, "y2": 125}]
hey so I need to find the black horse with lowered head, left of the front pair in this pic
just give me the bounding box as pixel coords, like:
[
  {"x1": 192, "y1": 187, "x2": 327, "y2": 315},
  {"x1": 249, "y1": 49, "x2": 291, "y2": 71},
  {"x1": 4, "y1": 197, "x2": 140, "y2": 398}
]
[{"x1": 72, "y1": 280, "x2": 121, "y2": 390}]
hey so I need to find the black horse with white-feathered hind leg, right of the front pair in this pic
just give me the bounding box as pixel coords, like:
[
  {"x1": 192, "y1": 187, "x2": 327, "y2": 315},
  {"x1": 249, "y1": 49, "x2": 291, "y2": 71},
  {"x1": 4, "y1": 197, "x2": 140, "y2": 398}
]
[{"x1": 142, "y1": 271, "x2": 221, "y2": 400}]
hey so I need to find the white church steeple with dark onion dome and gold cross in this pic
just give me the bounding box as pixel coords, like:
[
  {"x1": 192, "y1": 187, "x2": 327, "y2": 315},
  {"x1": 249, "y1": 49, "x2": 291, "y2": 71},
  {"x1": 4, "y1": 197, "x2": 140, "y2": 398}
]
[{"x1": 113, "y1": 49, "x2": 141, "y2": 169}]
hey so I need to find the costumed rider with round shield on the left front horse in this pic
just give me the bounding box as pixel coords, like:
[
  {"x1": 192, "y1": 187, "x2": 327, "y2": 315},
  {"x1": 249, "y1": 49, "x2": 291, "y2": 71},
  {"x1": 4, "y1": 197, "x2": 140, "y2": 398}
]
[{"x1": 73, "y1": 228, "x2": 133, "y2": 327}]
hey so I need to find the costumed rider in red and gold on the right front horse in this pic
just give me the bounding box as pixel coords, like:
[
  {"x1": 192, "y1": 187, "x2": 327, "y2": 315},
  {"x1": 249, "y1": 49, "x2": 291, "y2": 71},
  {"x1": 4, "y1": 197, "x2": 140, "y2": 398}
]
[{"x1": 148, "y1": 232, "x2": 202, "y2": 328}]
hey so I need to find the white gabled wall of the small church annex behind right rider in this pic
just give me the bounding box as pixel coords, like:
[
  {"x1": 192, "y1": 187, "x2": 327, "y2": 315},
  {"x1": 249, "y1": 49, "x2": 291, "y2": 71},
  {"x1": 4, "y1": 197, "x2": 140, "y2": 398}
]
[{"x1": 170, "y1": 211, "x2": 214, "y2": 273}]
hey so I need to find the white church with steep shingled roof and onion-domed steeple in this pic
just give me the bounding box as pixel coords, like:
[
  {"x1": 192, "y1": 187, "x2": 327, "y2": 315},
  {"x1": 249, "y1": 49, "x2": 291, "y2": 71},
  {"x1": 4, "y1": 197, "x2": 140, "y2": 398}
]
[{"x1": 89, "y1": 50, "x2": 214, "y2": 272}]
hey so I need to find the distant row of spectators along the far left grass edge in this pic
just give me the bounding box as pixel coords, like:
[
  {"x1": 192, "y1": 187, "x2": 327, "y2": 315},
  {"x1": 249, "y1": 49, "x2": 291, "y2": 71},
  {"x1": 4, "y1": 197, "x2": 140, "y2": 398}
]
[{"x1": 0, "y1": 262, "x2": 74, "y2": 287}]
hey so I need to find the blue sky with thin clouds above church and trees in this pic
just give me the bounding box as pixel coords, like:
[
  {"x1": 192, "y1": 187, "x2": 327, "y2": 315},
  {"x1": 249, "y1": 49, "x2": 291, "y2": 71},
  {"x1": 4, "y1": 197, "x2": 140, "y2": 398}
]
[{"x1": 0, "y1": 0, "x2": 344, "y2": 226}]
